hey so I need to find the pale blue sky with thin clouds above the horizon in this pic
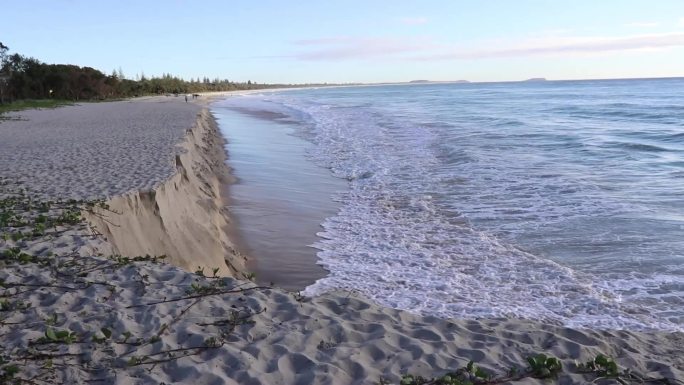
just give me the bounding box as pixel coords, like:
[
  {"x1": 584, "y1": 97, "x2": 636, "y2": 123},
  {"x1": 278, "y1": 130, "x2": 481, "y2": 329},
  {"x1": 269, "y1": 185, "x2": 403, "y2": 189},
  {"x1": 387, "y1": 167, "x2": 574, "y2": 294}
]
[{"x1": 0, "y1": 0, "x2": 684, "y2": 83}]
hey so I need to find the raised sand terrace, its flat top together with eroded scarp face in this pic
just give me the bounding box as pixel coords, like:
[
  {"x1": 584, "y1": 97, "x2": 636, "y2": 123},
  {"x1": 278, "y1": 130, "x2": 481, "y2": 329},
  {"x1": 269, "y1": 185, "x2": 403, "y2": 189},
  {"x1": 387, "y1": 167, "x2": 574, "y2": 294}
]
[{"x1": 0, "y1": 96, "x2": 245, "y2": 276}]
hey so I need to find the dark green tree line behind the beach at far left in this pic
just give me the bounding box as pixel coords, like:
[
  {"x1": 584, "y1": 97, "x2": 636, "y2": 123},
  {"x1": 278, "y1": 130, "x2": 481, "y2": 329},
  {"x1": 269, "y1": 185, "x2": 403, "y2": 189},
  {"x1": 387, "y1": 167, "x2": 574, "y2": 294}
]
[{"x1": 0, "y1": 42, "x2": 296, "y2": 103}]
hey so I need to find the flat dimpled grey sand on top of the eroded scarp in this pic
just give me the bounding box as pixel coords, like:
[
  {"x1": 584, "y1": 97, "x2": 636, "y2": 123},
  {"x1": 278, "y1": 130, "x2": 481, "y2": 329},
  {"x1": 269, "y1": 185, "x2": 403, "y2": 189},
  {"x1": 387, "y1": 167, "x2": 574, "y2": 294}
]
[{"x1": 0, "y1": 97, "x2": 201, "y2": 199}]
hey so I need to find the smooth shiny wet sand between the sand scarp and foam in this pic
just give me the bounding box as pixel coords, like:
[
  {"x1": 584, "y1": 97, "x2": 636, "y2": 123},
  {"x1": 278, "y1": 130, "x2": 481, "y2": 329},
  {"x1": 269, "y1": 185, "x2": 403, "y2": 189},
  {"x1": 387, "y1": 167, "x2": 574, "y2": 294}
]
[{"x1": 212, "y1": 103, "x2": 347, "y2": 290}]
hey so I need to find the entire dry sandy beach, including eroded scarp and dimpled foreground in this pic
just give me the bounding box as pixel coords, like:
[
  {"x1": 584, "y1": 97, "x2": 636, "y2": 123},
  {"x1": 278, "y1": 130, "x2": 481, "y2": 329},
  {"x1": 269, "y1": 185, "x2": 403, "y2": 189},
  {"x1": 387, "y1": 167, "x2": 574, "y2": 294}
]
[{"x1": 0, "y1": 97, "x2": 684, "y2": 384}]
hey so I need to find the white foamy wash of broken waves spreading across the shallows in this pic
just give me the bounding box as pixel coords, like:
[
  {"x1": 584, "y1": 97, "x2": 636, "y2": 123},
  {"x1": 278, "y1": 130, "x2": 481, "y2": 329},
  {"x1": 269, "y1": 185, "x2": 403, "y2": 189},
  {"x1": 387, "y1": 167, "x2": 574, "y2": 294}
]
[{"x1": 226, "y1": 91, "x2": 684, "y2": 330}]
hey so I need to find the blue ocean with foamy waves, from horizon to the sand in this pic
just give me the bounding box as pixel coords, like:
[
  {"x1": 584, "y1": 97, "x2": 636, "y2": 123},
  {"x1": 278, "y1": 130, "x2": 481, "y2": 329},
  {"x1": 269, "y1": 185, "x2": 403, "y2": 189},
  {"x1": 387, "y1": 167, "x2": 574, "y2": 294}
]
[{"x1": 212, "y1": 79, "x2": 684, "y2": 331}]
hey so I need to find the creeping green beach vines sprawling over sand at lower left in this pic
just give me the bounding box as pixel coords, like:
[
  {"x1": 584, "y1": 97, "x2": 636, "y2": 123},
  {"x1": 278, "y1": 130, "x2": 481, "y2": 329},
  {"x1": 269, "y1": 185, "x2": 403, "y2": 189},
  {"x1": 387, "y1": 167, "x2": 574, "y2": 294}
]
[{"x1": 0, "y1": 180, "x2": 270, "y2": 385}]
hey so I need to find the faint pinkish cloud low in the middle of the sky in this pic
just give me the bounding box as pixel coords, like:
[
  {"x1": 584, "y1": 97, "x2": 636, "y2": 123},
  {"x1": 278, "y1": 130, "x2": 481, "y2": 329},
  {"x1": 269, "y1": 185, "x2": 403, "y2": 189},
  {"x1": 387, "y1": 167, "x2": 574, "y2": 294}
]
[{"x1": 293, "y1": 36, "x2": 433, "y2": 61}]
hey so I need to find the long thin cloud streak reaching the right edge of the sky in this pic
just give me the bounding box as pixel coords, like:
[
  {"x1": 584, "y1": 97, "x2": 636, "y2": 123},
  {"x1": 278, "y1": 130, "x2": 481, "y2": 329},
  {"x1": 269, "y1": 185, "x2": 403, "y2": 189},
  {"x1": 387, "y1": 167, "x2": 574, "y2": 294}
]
[{"x1": 416, "y1": 32, "x2": 684, "y2": 60}]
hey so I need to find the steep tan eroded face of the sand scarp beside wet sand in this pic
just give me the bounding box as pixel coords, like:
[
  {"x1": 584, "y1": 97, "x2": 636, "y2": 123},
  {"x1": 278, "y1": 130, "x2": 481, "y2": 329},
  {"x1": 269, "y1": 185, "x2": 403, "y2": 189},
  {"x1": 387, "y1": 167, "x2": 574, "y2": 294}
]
[{"x1": 85, "y1": 108, "x2": 246, "y2": 277}]
